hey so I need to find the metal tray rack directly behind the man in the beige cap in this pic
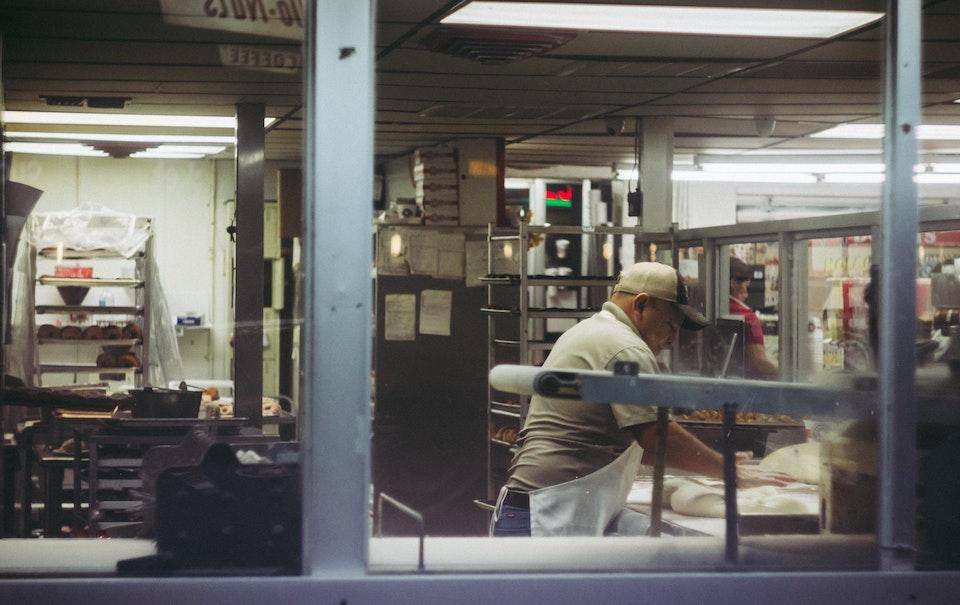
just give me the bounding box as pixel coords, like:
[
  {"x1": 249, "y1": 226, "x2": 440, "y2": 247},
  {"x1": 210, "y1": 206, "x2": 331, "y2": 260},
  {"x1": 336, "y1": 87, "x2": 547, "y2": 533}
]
[{"x1": 479, "y1": 220, "x2": 639, "y2": 498}]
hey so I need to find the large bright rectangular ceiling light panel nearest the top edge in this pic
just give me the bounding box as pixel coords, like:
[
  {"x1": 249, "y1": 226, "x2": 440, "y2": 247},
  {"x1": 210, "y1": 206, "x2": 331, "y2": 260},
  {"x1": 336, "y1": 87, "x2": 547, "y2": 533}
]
[{"x1": 440, "y1": 1, "x2": 883, "y2": 38}]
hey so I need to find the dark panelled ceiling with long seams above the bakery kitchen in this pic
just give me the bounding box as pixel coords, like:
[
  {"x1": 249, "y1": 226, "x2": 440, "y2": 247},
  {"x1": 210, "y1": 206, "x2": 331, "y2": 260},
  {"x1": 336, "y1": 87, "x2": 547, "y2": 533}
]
[{"x1": 0, "y1": 0, "x2": 960, "y2": 166}]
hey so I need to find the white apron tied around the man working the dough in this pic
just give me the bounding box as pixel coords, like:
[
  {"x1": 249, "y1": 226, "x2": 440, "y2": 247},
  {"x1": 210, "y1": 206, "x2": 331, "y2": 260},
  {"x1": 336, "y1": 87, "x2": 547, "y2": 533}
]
[{"x1": 510, "y1": 442, "x2": 643, "y2": 537}]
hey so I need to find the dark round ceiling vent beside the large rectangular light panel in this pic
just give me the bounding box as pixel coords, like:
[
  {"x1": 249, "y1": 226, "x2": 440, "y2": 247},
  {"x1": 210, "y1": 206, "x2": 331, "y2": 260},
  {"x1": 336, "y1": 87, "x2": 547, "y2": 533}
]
[{"x1": 420, "y1": 25, "x2": 577, "y2": 65}]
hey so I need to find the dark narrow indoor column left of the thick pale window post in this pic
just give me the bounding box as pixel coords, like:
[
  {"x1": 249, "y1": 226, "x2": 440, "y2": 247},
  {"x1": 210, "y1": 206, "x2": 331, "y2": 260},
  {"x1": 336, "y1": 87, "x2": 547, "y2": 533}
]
[{"x1": 233, "y1": 103, "x2": 265, "y2": 427}]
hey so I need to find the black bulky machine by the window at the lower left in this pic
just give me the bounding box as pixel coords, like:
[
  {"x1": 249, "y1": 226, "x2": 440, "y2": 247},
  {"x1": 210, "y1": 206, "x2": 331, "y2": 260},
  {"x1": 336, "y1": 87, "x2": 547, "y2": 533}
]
[{"x1": 117, "y1": 433, "x2": 301, "y2": 576}]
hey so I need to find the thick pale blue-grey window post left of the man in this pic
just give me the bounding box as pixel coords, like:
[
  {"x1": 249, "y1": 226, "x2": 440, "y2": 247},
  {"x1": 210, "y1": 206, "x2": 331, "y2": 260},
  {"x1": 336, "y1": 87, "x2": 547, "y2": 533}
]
[{"x1": 301, "y1": 0, "x2": 374, "y2": 577}]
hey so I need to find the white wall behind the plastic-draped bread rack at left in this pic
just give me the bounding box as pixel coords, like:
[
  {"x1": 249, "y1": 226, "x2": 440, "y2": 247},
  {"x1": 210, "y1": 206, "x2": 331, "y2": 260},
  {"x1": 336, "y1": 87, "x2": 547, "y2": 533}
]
[{"x1": 11, "y1": 153, "x2": 279, "y2": 379}]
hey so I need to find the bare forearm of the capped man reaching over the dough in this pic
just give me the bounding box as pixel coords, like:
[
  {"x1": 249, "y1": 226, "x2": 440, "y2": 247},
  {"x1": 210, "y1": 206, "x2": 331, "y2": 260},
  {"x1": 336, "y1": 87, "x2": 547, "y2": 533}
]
[{"x1": 627, "y1": 421, "x2": 795, "y2": 487}]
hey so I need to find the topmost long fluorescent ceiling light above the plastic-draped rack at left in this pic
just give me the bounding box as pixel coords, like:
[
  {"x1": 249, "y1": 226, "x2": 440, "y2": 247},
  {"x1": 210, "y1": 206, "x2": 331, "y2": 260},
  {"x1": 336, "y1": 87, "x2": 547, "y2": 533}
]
[{"x1": 2, "y1": 111, "x2": 276, "y2": 128}]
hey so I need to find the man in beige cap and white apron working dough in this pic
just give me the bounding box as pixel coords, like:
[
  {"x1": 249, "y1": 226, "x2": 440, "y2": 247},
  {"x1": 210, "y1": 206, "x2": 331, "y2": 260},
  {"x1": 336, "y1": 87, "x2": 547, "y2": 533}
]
[{"x1": 492, "y1": 262, "x2": 789, "y2": 536}]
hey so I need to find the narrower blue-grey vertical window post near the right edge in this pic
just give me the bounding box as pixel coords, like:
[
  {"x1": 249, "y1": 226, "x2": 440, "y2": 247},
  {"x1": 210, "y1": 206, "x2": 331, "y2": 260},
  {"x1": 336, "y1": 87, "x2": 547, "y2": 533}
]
[{"x1": 877, "y1": 0, "x2": 921, "y2": 571}]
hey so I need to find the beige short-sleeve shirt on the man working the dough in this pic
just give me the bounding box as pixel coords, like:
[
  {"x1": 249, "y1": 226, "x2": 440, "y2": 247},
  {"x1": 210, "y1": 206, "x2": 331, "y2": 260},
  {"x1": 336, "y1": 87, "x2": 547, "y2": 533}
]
[{"x1": 507, "y1": 302, "x2": 658, "y2": 491}]
